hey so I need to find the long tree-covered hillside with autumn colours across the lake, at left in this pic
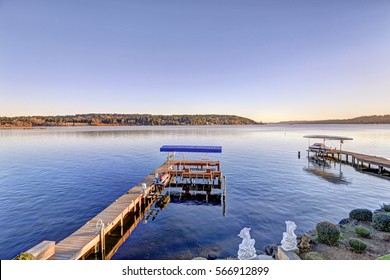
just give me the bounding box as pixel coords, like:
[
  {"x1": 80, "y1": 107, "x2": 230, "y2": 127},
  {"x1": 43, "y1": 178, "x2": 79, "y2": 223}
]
[{"x1": 0, "y1": 114, "x2": 257, "y2": 127}]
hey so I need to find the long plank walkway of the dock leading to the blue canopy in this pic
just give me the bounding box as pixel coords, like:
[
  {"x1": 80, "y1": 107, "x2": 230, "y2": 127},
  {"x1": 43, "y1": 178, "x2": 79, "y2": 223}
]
[{"x1": 50, "y1": 162, "x2": 169, "y2": 260}]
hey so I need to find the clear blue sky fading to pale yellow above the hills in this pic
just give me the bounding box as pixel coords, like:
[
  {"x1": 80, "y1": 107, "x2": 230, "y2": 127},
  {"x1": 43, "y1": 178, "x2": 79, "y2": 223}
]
[{"x1": 0, "y1": 0, "x2": 390, "y2": 121}]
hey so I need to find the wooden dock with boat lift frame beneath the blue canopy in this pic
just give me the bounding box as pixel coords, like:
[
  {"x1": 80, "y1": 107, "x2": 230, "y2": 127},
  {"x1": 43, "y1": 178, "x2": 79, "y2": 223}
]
[{"x1": 23, "y1": 158, "x2": 226, "y2": 260}]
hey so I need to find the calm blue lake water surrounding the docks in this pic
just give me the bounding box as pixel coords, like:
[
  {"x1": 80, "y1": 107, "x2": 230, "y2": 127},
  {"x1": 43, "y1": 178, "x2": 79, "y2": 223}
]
[{"x1": 0, "y1": 125, "x2": 390, "y2": 259}]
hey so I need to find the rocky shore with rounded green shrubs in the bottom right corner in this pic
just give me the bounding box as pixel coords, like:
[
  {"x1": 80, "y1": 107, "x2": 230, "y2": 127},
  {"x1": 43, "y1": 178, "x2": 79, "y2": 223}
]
[{"x1": 264, "y1": 204, "x2": 390, "y2": 260}]
